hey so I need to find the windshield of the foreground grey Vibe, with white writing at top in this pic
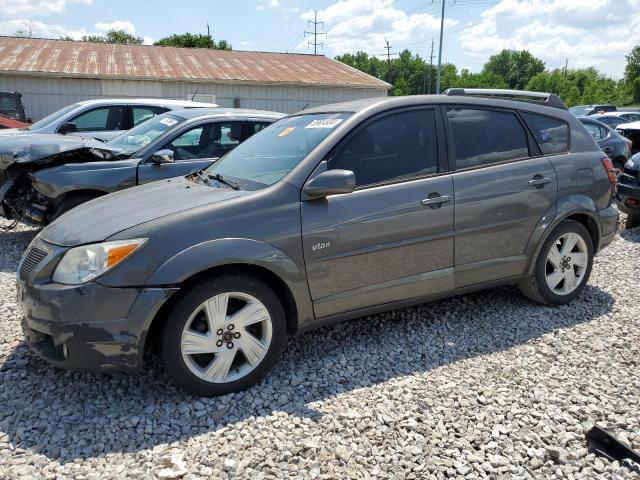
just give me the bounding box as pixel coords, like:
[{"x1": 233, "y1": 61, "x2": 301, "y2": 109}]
[{"x1": 207, "y1": 113, "x2": 351, "y2": 188}]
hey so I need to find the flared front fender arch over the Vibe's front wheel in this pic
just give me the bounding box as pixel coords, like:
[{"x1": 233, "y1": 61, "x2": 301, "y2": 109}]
[{"x1": 145, "y1": 238, "x2": 313, "y2": 325}]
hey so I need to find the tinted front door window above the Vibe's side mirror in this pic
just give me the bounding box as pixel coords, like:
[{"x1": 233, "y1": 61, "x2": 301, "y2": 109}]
[{"x1": 329, "y1": 109, "x2": 438, "y2": 187}]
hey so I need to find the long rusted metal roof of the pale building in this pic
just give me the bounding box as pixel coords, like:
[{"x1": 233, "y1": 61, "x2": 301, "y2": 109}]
[{"x1": 0, "y1": 37, "x2": 390, "y2": 88}]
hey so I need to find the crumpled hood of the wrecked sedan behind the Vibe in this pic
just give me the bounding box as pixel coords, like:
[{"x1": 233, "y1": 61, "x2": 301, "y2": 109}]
[{"x1": 0, "y1": 134, "x2": 120, "y2": 169}]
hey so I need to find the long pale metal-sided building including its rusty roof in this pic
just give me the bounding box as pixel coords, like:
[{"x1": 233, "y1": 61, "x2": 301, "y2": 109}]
[{"x1": 0, "y1": 37, "x2": 391, "y2": 120}]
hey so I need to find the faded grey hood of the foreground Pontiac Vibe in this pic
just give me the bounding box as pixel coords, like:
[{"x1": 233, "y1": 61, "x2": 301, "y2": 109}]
[{"x1": 40, "y1": 177, "x2": 248, "y2": 247}]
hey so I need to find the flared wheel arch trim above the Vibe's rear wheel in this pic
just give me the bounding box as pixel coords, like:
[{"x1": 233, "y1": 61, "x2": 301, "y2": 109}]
[{"x1": 527, "y1": 195, "x2": 602, "y2": 275}]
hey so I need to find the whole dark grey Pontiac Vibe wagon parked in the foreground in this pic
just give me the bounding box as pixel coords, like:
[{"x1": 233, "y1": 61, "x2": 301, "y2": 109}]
[{"x1": 18, "y1": 90, "x2": 618, "y2": 395}]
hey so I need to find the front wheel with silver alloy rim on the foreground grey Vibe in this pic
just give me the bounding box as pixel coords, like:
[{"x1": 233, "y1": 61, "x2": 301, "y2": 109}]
[{"x1": 161, "y1": 275, "x2": 286, "y2": 396}]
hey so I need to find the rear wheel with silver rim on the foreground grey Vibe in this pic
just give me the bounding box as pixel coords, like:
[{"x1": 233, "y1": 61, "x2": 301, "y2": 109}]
[{"x1": 520, "y1": 220, "x2": 593, "y2": 305}]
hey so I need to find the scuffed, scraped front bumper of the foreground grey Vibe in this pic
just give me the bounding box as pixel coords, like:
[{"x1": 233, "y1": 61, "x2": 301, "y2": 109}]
[{"x1": 18, "y1": 281, "x2": 177, "y2": 370}]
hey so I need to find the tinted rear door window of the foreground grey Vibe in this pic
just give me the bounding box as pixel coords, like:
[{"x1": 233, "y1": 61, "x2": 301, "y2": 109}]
[{"x1": 447, "y1": 108, "x2": 529, "y2": 170}]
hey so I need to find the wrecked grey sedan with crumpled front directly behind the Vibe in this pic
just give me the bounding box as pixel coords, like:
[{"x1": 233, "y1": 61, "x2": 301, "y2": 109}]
[{"x1": 0, "y1": 108, "x2": 284, "y2": 226}]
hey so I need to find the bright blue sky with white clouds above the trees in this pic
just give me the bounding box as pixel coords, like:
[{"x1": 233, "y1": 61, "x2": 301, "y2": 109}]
[{"x1": 0, "y1": 0, "x2": 640, "y2": 78}]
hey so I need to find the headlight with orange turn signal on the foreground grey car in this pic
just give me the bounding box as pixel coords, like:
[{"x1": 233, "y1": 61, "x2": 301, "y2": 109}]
[{"x1": 53, "y1": 238, "x2": 147, "y2": 285}]
